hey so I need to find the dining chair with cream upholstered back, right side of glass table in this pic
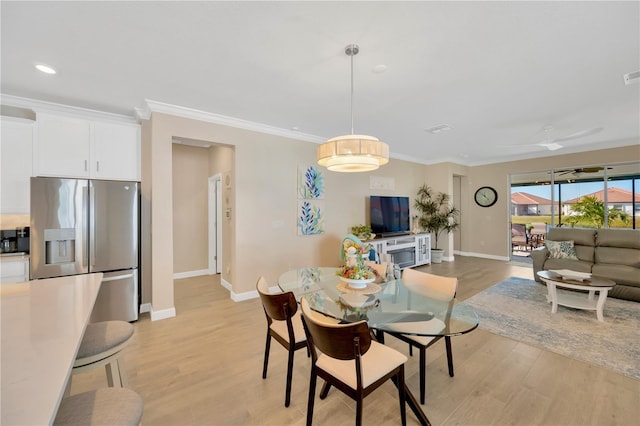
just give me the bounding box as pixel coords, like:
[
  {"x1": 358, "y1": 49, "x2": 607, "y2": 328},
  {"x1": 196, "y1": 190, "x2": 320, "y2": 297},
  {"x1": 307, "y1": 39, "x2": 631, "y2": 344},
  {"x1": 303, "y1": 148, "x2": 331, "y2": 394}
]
[{"x1": 385, "y1": 268, "x2": 458, "y2": 405}]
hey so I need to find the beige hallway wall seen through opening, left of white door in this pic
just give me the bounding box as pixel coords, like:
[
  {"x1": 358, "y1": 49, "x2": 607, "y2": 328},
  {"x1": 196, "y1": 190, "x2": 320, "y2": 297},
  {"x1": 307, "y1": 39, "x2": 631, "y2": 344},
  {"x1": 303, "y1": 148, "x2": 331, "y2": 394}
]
[{"x1": 172, "y1": 144, "x2": 209, "y2": 273}]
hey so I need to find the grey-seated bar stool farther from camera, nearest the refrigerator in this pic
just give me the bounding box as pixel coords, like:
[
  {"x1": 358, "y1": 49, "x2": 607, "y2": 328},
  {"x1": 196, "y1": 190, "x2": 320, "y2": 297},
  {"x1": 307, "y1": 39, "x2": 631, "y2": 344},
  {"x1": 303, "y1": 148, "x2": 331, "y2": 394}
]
[{"x1": 65, "y1": 321, "x2": 133, "y2": 395}]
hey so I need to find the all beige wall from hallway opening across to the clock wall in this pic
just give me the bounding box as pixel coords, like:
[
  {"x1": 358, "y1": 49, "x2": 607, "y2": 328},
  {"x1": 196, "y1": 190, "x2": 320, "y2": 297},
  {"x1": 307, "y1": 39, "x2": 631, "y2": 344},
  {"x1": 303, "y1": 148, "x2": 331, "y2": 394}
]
[{"x1": 143, "y1": 113, "x2": 639, "y2": 316}]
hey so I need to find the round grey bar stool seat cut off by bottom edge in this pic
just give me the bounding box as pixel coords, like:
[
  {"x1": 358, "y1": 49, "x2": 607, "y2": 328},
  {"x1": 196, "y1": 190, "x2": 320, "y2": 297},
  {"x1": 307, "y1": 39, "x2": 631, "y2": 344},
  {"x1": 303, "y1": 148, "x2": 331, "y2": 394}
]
[{"x1": 53, "y1": 388, "x2": 143, "y2": 426}]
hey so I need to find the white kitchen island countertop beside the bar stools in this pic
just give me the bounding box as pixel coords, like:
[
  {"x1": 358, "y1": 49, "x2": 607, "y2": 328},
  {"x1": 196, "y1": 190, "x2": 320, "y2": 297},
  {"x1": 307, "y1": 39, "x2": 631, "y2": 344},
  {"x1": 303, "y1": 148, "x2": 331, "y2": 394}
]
[{"x1": 0, "y1": 273, "x2": 102, "y2": 425}]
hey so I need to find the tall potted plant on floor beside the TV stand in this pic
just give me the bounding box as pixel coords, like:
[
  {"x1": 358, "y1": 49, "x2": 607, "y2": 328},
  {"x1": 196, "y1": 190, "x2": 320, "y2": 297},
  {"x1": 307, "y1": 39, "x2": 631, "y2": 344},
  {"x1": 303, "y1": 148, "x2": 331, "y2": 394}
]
[{"x1": 414, "y1": 185, "x2": 460, "y2": 263}]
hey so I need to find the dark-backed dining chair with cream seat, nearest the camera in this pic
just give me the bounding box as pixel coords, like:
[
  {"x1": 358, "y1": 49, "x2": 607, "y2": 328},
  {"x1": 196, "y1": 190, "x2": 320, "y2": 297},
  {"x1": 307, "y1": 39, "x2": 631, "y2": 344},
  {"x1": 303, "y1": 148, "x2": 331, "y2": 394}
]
[{"x1": 300, "y1": 297, "x2": 407, "y2": 426}]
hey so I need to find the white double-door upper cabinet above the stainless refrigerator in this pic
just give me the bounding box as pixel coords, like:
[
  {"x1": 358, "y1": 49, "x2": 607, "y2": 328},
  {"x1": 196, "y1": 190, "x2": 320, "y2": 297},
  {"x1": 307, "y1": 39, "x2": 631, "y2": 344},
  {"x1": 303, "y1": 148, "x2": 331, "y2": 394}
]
[{"x1": 35, "y1": 113, "x2": 140, "y2": 181}]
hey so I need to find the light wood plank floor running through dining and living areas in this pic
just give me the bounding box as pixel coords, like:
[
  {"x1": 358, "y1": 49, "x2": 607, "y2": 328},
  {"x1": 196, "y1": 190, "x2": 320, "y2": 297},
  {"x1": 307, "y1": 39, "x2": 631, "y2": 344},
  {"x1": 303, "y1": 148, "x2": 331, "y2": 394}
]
[{"x1": 71, "y1": 257, "x2": 640, "y2": 425}]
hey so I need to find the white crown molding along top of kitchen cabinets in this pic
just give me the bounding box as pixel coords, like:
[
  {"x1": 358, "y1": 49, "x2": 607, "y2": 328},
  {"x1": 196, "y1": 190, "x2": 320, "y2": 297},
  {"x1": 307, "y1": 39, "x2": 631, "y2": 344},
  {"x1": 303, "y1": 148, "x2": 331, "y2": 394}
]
[{"x1": 0, "y1": 94, "x2": 138, "y2": 124}]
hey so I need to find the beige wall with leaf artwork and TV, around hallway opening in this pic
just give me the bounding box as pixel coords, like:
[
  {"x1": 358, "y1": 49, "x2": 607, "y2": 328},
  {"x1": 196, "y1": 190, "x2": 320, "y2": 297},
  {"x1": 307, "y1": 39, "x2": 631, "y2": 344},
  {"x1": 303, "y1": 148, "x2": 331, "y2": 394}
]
[{"x1": 143, "y1": 113, "x2": 425, "y2": 311}]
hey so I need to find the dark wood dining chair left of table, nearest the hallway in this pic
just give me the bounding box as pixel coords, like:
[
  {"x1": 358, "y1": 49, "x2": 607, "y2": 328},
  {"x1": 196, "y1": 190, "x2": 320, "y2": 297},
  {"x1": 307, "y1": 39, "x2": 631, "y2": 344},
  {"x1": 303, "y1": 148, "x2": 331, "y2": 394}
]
[{"x1": 256, "y1": 277, "x2": 308, "y2": 407}]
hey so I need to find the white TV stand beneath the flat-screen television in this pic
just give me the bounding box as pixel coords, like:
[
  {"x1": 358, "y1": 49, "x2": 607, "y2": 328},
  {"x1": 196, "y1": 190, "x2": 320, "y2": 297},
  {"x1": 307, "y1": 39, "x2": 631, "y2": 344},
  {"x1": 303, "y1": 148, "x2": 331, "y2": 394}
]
[{"x1": 367, "y1": 233, "x2": 431, "y2": 269}]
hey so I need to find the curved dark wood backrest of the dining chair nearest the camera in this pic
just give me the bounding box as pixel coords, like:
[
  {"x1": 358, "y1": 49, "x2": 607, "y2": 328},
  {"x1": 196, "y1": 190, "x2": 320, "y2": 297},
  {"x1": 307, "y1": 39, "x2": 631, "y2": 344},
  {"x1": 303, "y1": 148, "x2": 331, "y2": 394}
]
[{"x1": 300, "y1": 297, "x2": 371, "y2": 361}]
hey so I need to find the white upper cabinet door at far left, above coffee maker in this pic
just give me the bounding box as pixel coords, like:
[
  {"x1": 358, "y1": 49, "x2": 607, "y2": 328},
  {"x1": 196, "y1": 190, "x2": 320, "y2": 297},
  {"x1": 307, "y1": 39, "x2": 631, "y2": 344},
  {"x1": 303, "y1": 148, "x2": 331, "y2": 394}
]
[{"x1": 0, "y1": 118, "x2": 34, "y2": 214}]
